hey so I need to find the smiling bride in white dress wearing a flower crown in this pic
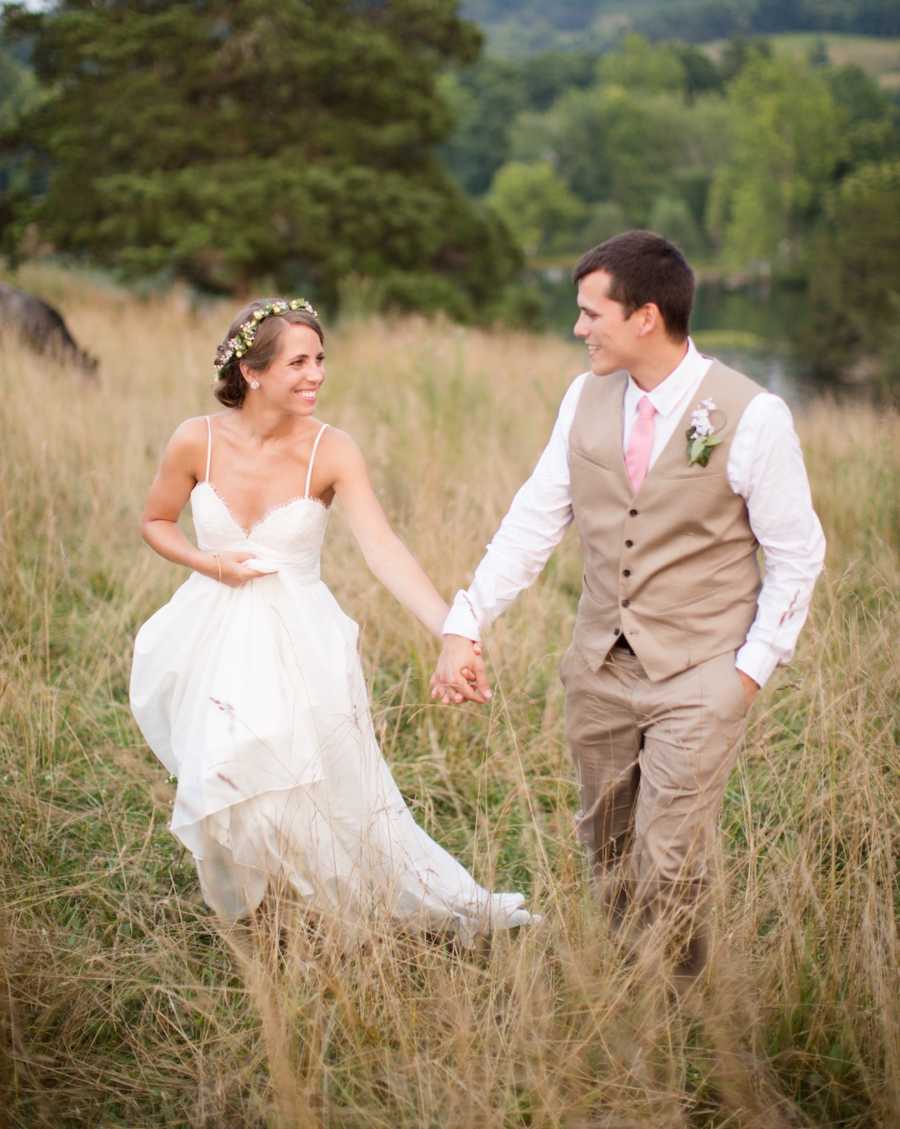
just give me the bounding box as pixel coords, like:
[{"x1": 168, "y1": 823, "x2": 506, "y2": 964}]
[{"x1": 131, "y1": 299, "x2": 536, "y2": 943}]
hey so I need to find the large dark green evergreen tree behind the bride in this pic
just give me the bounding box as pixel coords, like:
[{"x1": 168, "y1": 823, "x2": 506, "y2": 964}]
[{"x1": 6, "y1": 0, "x2": 518, "y2": 308}]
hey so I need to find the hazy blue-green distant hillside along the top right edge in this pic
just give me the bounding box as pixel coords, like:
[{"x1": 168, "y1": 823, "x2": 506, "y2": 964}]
[{"x1": 462, "y1": 0, "x2": 900, "y2": 55}]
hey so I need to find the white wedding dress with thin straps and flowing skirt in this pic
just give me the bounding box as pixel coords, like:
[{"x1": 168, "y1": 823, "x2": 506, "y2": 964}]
[{"x1": 131, "y1": 419, "x2": 539, "y2": 944}]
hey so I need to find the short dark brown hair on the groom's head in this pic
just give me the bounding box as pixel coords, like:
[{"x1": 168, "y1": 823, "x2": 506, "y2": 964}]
[{"x1": 573, "y1": 231, "x2": 694, "y2": 341}]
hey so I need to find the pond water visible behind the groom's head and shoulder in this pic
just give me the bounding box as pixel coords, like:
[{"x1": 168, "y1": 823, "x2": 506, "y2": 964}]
[{"x1": 536, "y1": 270, "x2": 835, "y2": 406}]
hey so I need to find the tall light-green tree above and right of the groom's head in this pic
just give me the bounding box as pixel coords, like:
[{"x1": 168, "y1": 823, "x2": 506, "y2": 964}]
[{"x1": 709, "y1": 56, "x2": 846, "y2": 266}]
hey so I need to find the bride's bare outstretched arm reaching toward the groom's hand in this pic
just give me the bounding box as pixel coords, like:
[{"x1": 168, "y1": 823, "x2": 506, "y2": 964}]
[{"x1": 320, "y1": 428, "x2": 449, "y2": 637}]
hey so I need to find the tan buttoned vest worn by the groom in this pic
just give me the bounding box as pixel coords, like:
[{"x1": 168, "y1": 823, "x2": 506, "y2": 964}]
[{"x1": 569, "y1": 360, "x2": 763, "y2": 682}]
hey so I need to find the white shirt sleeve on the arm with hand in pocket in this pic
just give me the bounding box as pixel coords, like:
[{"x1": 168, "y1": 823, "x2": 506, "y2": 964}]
[{"x1": 728, "y1": 394, "x2": 825, "y2": 685}]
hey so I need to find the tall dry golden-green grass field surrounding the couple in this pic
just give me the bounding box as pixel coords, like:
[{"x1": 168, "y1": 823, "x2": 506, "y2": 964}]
[{"x1": 0, "y1": 271, "x2": 900, "y2": 1129}]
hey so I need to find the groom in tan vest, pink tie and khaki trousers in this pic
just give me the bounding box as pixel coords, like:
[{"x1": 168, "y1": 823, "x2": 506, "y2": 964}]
[{"x1": 431, "y1": 231, "x2": 824, "y2": 977}]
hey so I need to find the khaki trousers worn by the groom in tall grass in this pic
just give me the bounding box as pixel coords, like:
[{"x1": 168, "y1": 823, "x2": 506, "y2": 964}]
[{"x1": 560, "y1": 646, "x2": 746, "y2": 974}]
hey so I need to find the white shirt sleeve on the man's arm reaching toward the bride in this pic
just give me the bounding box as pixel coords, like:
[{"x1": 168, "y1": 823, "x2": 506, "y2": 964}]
[{"x1": 444, "y1": 373, "x2": 588, "y2": 639}]
